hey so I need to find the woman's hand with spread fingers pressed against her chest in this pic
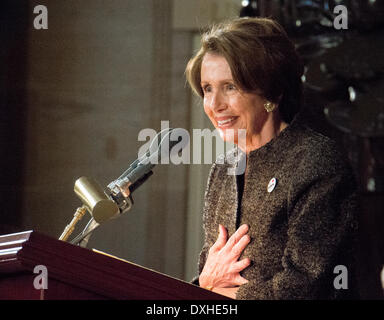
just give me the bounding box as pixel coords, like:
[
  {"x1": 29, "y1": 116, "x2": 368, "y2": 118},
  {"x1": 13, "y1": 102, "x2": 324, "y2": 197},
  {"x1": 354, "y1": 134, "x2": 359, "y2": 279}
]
[{"x1": 199, "y1": 224, "x2": 251, "y2": 297}]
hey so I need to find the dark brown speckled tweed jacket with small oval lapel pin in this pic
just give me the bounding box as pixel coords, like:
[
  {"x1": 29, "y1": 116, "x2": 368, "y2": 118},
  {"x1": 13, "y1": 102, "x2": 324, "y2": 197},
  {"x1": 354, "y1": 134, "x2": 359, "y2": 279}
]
[{"x1": 199, "y1": 120, "x2": 357, "y2": 299}]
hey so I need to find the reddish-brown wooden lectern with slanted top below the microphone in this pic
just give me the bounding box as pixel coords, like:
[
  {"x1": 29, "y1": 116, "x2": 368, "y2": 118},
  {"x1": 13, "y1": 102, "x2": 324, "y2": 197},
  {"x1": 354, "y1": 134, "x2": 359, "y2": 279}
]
[{"x1": 0, "y1": 231, "x2": 229, "y2": 300}]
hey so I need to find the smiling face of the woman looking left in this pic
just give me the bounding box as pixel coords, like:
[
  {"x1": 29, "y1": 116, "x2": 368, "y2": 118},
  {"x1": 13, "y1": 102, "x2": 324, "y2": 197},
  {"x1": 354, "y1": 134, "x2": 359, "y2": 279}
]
[{"x1": 201, "y1": 53, "x2": 268, "y2": 148}]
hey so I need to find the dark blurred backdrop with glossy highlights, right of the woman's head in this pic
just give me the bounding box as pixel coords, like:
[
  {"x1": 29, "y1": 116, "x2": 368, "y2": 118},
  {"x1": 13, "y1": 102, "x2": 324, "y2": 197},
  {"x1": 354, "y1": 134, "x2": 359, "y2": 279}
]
[{"x1": 241, "y1": 0, "x2": 384, "y2": 299}]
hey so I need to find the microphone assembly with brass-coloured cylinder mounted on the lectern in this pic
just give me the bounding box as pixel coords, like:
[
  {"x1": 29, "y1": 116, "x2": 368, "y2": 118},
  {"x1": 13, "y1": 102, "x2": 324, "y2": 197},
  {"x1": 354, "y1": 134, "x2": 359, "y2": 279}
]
[{"x1": 65, "y1": 128, "x2": 189, "y2": 246}]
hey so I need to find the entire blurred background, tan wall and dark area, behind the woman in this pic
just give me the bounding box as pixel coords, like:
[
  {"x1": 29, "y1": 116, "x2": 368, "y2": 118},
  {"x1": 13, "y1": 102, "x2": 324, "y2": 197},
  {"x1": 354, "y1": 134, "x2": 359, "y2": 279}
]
[{"x1": 0, "y1": 0, "x2": 384, "y2": 299}]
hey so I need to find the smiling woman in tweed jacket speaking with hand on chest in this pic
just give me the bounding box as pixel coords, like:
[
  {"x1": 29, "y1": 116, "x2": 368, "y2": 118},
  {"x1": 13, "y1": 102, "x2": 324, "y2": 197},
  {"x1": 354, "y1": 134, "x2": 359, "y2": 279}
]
[{"x1": 186, "y1": 18, "x2": 356, "y2": 299}]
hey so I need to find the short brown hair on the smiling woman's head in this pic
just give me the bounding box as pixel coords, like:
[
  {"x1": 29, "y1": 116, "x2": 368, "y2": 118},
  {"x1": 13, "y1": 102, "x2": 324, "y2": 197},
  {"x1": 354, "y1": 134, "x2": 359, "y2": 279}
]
[{"x1": 186, "y1": 18, "x2": 303, "y2": 122}]
